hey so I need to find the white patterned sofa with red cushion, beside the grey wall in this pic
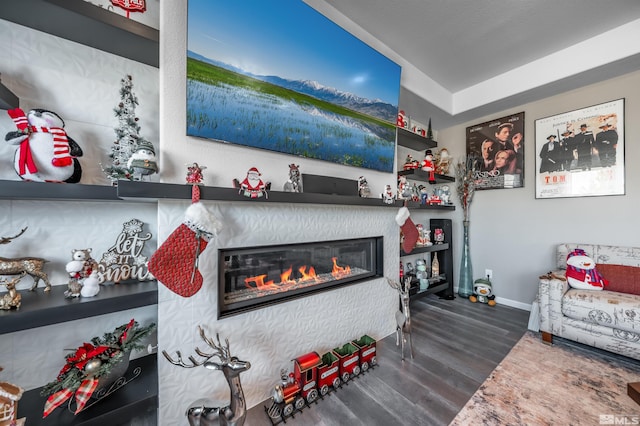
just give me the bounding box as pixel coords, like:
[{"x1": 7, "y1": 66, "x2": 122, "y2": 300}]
[{"x1": 538, "y1": 244, "x2": 640, "y2": 359}]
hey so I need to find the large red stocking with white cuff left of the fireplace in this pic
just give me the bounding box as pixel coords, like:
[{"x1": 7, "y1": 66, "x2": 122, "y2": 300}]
[{"x1": 149, "y1": 202, "x2": 220, "y2": 297}]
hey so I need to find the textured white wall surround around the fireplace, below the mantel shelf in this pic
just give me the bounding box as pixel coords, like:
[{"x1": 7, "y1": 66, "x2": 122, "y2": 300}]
[{"x1": 158, "y1": 201, "x2": 398, "y2": 425}]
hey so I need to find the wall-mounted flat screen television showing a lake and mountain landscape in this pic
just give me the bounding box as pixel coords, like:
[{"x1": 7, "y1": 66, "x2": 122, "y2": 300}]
[{"x1": 187, "y1": 0, "x2": 401, "y2": 172}]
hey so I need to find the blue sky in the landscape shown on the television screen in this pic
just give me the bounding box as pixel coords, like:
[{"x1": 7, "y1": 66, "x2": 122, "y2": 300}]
[{"x1": 188, "y1": 0, "x2": 400, "y2": 106}]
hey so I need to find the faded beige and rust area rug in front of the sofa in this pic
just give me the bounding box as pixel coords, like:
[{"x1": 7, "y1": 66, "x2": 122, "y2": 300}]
[{"x1": 451, "y1": 331, "x2": 640, "y2": 425}]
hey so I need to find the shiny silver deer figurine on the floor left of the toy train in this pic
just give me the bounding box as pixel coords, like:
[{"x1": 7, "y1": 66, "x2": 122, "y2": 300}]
[{"x1": 162, "y1": 326, "x2": 251, "y2": 426}]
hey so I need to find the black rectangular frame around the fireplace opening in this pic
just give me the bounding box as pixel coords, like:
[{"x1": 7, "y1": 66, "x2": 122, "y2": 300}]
[{"x1": 218, "y1": 236, "x2": 384, "y2": 319}]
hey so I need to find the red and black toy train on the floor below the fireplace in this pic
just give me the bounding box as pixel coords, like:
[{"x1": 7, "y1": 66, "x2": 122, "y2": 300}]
[{"x1": 265, "y1": 334, "x2": 377, "y2": 424}]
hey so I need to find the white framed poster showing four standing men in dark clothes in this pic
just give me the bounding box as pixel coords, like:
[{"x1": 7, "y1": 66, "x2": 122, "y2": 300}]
[{"x1": 535, "y1": 99, "x2": 625, "y2": 198}]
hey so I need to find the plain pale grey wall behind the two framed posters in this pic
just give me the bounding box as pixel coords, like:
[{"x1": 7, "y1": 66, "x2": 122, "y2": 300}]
[{"x1": 439, "y1": 72, "x2": 640, "y2": 307}]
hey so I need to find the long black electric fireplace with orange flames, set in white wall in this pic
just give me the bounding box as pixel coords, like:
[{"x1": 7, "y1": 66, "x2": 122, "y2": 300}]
[{"x1": 218, "y1": 237, "x2": 384, "y2": 318}]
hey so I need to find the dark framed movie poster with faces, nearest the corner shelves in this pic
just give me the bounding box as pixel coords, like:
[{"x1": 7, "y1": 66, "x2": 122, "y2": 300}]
[{"x1": 467, "y1": 112, "x2": 524, "y2": 190}]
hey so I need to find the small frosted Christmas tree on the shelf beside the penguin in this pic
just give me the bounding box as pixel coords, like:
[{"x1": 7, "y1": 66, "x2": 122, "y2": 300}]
[{"x1": 103, "y1": 75, "x2": 150, "y2": 184}]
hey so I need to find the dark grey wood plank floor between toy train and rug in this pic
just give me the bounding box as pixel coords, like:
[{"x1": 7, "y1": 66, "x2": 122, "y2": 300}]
[{"x1": 245, "y1": 296, "x2": 529, "y2": 426}]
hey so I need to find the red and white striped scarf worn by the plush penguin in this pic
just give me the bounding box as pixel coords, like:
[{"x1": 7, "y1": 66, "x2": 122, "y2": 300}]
[{"x1": 8, "y1": 108, "x2": 73, "y2": 176}]
